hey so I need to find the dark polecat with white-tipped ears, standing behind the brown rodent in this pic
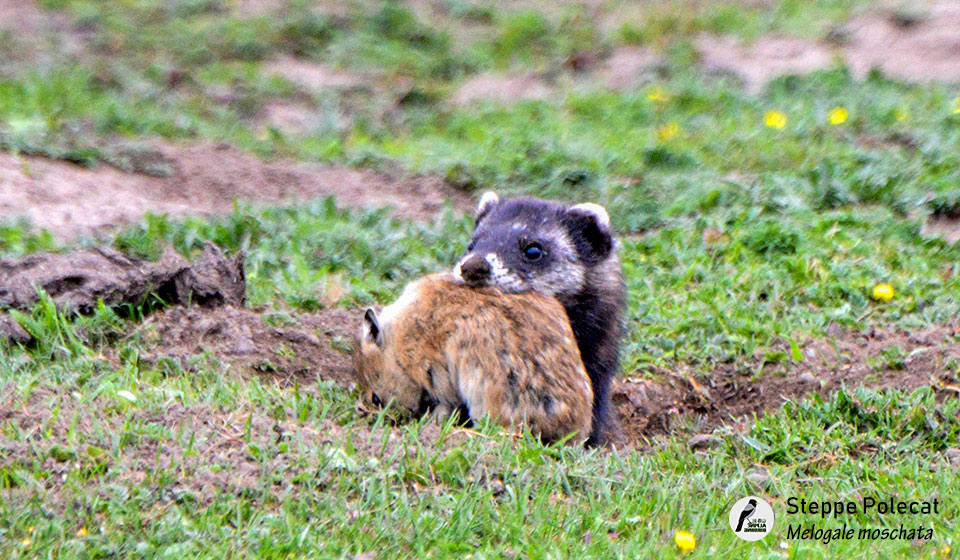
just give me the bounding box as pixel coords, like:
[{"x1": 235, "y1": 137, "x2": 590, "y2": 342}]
[{"x1": 454, "y1": 192, "x2": 626, "y2": 445}]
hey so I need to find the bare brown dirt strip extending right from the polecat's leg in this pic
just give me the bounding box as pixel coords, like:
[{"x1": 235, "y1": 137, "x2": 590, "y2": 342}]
[{"x1": 613, "y1": 326, "x2": 960, "y2": 446}]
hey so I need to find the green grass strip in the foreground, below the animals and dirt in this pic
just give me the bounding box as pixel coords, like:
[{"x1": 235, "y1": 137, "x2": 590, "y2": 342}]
[{"x1": 0, "y1": 308, "x2": 960, "y2": 558}]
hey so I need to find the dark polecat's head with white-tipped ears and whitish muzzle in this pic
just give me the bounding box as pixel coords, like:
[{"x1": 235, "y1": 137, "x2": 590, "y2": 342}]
[{"x1": 454, "y1": 192, "x2": 614, "y2": 296}]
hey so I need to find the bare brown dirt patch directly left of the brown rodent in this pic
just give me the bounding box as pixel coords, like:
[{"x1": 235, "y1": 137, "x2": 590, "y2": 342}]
[{"x1": 137, "y1": 306, "x2": 360, "y2": 386}]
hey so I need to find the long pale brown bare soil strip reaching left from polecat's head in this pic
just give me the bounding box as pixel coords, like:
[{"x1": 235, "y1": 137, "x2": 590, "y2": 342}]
[{"x1": 0, "y1": 143, "x2": 472, "y2": 240}]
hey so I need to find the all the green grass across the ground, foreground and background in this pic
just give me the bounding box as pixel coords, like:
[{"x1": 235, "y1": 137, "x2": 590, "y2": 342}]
[{"x1": 0, "y1": 0, "x2": 960, "y2": 558}]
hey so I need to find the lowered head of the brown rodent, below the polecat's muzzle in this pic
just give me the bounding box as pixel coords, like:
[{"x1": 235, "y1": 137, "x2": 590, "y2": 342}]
[{"x1": 353, "y1": 308, "x2": 431, "y2": 418}]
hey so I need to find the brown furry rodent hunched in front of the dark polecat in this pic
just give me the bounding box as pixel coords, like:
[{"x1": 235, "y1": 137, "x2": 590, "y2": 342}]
[{"x1": 355, "y1": 274, "x2": 593, "y2": 442}]
